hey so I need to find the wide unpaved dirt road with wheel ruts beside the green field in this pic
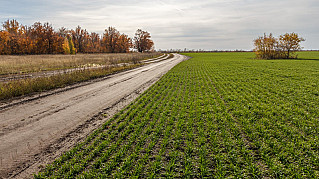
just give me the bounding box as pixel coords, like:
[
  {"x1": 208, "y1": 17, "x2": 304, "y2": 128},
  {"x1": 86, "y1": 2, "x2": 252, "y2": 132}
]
[{"x1": 0, "y1": 54, "x2": 187, "y2": 178}]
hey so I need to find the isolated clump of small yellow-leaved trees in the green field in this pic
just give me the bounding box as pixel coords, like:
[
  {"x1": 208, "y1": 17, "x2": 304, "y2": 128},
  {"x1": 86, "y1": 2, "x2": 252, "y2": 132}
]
[{"x1": 254, "y1": 33, "x2": 305, "y2": 59}]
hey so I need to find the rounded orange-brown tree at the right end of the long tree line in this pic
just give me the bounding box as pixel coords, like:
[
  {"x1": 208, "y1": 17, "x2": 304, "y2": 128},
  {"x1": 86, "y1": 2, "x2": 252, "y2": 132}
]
[{"x1": 134, "y1": 29, "x2": 154, "y2": 52}]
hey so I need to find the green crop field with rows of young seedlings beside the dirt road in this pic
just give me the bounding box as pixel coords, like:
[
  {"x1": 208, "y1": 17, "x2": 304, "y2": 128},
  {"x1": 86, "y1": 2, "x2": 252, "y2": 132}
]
[{"x1": 35, "y1": 52, "x2": 319, "y2": 178}]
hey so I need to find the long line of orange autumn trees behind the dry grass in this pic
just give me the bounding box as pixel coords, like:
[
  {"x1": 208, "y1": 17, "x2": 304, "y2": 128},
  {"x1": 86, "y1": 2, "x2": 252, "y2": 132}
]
[{"x1": 0, "y1": 20, "x2": 154, "y2": 55}]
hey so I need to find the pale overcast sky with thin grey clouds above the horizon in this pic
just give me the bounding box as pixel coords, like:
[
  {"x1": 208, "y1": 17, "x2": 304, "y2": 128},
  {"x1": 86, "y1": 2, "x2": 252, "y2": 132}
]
[{"x1": 0, "y1": 0, "x2": 319, "y2": 50}]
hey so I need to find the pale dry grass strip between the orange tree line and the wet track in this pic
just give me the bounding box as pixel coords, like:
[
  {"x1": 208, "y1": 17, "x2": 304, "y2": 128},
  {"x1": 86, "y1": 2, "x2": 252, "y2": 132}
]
[{"x1": 0, "y1": 53, "x2": 160, "y2": 75}]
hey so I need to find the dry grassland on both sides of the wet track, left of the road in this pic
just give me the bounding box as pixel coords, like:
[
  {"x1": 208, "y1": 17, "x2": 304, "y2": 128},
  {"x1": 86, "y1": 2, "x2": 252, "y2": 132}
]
[{"x1": 0, "y1": 53, "x2": 161, "y2": 100}]
